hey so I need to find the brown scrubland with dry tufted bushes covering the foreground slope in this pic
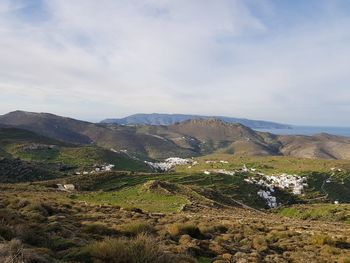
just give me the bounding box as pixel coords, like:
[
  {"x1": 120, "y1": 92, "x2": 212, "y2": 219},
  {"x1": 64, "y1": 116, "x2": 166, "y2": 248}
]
[{"x1": 0, "y1": 185, "x2": 350, "y2": 263}]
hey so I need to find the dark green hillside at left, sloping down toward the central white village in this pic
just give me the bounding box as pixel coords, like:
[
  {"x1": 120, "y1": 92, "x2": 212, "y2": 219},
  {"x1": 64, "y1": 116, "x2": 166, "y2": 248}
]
[{"x1": 0, "y1": 128, "x2": 149, "y2": 176}]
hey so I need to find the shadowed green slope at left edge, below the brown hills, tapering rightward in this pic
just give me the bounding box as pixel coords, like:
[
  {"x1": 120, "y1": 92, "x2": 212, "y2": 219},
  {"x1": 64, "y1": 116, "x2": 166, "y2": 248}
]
[{"x1": 0, "y1": 128, "x2": 150, "y2": 185}]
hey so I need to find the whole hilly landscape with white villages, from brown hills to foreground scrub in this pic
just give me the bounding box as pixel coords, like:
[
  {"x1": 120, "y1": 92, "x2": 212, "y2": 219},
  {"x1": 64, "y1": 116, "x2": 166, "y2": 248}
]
[{"x1": 0, "y1": 112, "x2": 350, "y2": 263}]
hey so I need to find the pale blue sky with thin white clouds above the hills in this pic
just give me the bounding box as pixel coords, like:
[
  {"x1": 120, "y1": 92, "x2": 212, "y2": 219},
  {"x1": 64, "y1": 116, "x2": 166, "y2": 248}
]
[{"x1": 0, "y1": 0, "x2": 350, "y2": 126}]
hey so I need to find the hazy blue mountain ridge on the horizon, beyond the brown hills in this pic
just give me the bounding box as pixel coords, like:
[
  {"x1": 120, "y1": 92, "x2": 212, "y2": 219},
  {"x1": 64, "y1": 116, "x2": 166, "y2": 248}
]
[{"x1": 101, "y1": 113, "x2": 291, "y2": 129}]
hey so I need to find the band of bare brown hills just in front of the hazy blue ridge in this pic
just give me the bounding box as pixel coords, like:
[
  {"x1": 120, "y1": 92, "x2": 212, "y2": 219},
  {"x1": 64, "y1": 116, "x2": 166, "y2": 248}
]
[{"x1": 0, "y1": 111, "x2": 350, "y2": 160}]
